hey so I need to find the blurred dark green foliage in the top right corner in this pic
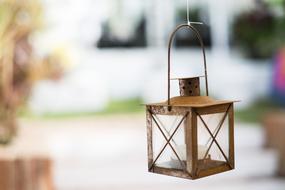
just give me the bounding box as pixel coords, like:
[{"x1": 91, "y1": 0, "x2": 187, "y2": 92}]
[{"x1": 233, "y1": 1, "x2": 285, "y2": 59}]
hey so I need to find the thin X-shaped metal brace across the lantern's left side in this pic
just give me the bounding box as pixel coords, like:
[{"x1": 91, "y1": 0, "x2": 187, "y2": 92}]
[{"x1": 148, "y1": 110, "x2": 189, "y2": 171}]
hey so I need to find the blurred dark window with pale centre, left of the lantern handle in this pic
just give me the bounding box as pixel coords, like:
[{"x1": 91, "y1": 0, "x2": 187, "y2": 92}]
[{"x1": 97, "y1": 0, "x2": 147, "y2": 48}]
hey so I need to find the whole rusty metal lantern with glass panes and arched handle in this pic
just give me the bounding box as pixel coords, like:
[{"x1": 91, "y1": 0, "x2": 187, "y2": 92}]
[{"x1": 146, "y1": 24, "x2": 235, "y2": 179}]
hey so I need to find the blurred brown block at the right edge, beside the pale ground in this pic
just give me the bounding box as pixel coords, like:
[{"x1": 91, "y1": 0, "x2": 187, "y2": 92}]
[{"x1": 263, "y1": 112, "x2": 285, "y2": 176}]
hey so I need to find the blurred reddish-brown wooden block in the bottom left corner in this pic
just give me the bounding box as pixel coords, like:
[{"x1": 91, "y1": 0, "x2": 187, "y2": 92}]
[{"x1": 0, "y1": 157, "x2": 54, "y2": 190}]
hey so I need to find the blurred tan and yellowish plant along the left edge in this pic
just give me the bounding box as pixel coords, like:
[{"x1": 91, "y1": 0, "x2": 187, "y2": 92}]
[{"x1": 0, "y1": 0, "x2": 63, "y2": 144}]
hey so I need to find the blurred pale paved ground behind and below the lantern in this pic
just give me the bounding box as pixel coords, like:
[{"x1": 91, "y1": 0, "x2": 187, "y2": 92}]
[{"x1": 14, "y1": 115, "x2": 285, "y2": 190}]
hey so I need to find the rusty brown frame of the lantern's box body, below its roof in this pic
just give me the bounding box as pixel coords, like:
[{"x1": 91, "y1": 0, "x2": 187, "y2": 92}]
[{"x1": 146, "y1": 103, "x2": 234, "y2": 179}]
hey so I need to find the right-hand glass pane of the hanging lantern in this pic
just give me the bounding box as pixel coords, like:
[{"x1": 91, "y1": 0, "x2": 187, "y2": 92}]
[{"x1": 197, "y1": 113, "x2": 229, "y2": 169}]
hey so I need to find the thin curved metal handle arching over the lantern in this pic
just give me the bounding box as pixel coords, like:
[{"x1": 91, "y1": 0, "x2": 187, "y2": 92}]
[{"x1": 167, "y1": 24, "x2": 209, "y2": 110}]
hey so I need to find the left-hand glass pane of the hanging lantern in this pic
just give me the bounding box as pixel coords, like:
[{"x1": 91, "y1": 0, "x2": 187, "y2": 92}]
[{"x1": 153, "y1": 115, "x2": 186, "y2": 170}]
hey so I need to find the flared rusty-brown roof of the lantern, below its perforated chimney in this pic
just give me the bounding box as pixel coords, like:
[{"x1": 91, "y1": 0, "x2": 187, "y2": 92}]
[{"x1": 147, "y1": 96, "x2": 238, "y2": 108}]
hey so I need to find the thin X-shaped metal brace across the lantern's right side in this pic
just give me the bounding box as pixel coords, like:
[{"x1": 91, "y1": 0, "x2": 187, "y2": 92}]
[{"x1": 195, "y1": 105, "x2": 233, "y2": 168}]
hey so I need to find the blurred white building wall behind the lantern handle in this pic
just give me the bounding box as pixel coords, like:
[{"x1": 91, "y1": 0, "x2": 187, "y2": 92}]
[{"x1": 30, "y1": 0, "x2": 270, "y2": 113}]
